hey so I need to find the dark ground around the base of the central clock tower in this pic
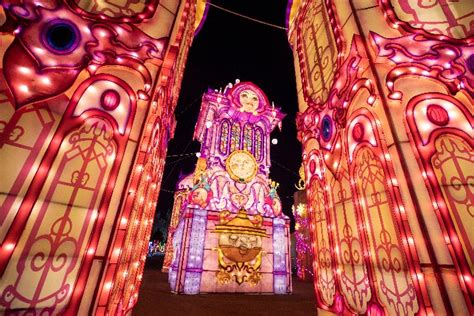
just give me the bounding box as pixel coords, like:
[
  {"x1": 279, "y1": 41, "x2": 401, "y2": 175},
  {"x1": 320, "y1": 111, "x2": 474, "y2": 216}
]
[{"x1": 133, "y1": 259, "x2": 316, "y2": 316}]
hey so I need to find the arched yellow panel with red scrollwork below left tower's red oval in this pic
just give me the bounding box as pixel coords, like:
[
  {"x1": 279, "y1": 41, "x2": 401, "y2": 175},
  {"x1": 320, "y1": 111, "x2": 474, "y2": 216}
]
[{"x1": 0, "y1": 118, "x2": 117, "y2": 313}]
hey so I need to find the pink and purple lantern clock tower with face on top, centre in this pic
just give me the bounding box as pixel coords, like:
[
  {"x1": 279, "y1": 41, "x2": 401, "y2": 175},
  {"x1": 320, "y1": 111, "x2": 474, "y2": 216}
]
[{"x1": 169, "y1": 82, "x2": 291, "y2": 294}]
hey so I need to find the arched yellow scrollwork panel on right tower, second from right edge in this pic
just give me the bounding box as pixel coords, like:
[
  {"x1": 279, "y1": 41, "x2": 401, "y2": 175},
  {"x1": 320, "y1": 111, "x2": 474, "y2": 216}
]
[{"x1": 354, "y1": 148, "x2": 418, "y2": 315}]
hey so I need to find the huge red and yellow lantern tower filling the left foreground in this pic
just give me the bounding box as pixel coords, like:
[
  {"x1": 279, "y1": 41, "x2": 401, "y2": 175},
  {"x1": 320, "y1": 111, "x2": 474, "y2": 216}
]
[{"x1": 0, "y1": 0, "x2": 205, "y2": 315}]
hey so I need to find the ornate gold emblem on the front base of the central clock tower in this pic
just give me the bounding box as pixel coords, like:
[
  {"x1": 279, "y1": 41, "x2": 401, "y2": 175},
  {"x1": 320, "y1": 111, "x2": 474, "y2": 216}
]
[{"x1": 213, "y1": 209, "x2": 267, "y2": 286}]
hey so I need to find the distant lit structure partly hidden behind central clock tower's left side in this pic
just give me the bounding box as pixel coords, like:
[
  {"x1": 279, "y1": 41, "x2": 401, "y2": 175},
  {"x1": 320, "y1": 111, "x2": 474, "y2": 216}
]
[{"x1": 161, "y1": 174, "x2": 194, "y2": 272}]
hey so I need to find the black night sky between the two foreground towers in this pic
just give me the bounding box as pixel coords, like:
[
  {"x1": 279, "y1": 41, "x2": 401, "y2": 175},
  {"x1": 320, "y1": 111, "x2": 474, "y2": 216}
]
[{"x1": 152, "y1": 0, "x2": 301, "y2": 238}]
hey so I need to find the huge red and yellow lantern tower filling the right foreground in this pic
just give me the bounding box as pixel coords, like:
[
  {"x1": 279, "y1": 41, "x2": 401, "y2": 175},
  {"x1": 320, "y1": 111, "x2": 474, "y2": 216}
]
[{"x1": 287, "y1": 0, "x2": 474, "y2": 315}]
